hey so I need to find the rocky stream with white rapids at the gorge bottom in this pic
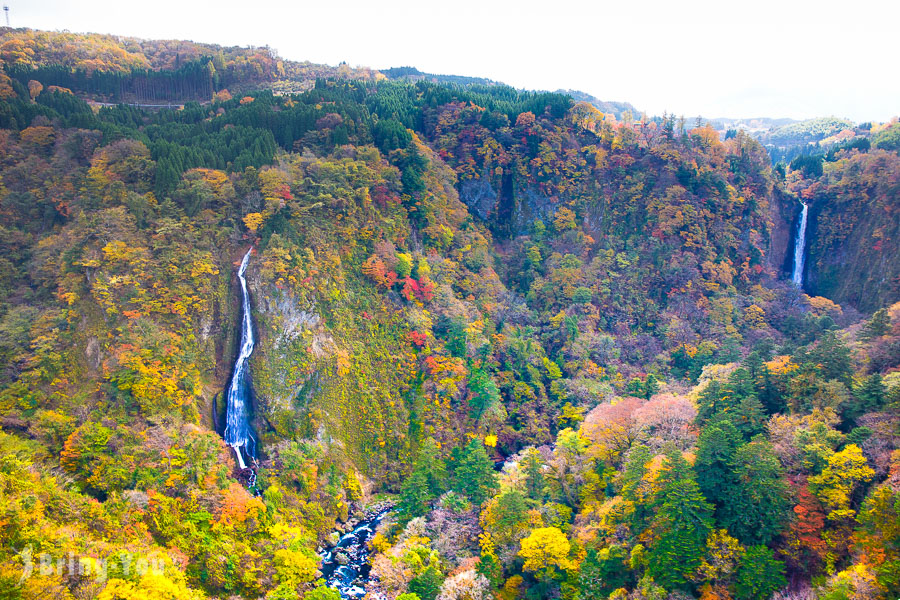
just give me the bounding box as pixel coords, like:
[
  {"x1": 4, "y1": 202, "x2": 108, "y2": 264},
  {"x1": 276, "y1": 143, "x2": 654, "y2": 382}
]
[{"x1": 319, "y1": 507, "x2": 391, "y2": 599}]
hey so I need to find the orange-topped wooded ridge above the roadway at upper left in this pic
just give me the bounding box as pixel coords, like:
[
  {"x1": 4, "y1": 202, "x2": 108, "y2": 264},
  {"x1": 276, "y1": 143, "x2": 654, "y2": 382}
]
[{"x1": 0, "y1": 28, "x2": 377, "y2": 103}]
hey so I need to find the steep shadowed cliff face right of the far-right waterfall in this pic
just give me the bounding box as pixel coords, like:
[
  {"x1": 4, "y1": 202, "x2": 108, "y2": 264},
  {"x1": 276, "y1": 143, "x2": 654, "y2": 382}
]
[{"x1": 804, "y1": 150, "x2": 900, "y2": 312}]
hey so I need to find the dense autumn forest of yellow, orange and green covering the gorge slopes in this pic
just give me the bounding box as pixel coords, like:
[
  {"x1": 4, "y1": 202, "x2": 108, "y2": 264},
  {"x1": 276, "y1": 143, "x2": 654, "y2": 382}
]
[{"x1": 0, "y1": 29, "x2": 900, "y2": 600}]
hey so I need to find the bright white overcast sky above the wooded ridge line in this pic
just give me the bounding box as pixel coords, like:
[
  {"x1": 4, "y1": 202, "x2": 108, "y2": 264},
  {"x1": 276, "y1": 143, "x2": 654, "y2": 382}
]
[{"x1": 3, "y1": 0, "x2": 900, "y2": 121}]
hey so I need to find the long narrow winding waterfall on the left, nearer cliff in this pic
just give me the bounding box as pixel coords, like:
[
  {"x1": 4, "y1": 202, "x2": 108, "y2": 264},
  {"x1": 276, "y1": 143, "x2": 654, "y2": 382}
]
[{"x1": 225, "y1": 248, "x2": 256, "y2": 469}]
